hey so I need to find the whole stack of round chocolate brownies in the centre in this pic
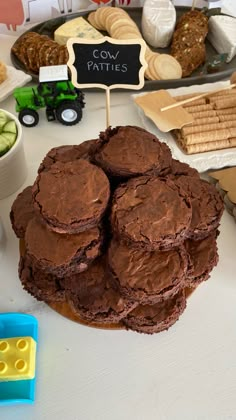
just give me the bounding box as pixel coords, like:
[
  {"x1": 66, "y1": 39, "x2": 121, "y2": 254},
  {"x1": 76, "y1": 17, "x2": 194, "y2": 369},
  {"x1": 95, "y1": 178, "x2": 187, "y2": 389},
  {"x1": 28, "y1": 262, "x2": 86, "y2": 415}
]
[{"x1": 10, "y1": 126, "x2": 224, "y2": 334}]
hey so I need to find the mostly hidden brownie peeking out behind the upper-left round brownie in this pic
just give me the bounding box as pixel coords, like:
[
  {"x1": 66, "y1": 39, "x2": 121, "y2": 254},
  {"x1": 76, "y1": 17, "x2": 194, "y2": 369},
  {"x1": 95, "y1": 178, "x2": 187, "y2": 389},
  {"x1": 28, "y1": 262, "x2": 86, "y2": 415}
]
[{"x1": 38, "y1": 140, "x2": 98, "y2": 173}]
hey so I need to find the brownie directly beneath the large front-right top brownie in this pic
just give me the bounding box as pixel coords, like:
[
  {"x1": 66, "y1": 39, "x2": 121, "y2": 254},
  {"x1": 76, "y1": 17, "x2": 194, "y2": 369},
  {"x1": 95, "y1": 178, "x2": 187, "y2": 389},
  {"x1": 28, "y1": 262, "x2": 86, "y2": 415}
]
[{"x1": 108, "y1": 241, "x2": 188, "y2": 305}]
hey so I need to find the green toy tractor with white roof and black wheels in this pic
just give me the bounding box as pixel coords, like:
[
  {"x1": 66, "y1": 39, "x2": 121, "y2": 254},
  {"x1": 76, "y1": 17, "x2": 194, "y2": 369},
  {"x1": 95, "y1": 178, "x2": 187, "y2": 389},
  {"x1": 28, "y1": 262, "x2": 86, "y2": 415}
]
[{"x1": 13, "y1": 65, "x2": 85, "y2": 127}]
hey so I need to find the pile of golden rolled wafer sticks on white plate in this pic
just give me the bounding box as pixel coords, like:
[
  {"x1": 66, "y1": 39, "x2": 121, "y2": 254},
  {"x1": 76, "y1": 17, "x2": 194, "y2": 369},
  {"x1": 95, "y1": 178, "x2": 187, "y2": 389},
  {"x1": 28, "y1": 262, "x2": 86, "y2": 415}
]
[{"x1": 174, "y1": 89, "x2": 236, "y2": 154}]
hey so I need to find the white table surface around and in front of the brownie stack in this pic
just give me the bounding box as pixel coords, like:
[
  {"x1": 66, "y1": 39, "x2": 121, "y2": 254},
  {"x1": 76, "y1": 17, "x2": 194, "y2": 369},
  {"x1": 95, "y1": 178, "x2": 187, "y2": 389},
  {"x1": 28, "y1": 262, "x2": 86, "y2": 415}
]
[{"x1": 0, "y1": 32, "x2": 236, "y2": 420}]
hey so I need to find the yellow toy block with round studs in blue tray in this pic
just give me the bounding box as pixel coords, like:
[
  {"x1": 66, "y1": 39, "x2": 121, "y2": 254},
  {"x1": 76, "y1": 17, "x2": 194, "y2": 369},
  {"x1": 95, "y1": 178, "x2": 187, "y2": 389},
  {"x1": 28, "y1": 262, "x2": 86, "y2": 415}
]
[{"x1": 0, "y1": 337, "x2": 36, "y2": 381}]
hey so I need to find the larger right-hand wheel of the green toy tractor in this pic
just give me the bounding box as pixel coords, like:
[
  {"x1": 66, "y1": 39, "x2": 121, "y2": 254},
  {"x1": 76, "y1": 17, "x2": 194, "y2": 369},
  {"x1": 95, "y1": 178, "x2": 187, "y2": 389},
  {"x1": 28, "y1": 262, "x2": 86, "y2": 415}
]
[{"x1": 56, "y1": 101, "x2": 82, "y2": 125}]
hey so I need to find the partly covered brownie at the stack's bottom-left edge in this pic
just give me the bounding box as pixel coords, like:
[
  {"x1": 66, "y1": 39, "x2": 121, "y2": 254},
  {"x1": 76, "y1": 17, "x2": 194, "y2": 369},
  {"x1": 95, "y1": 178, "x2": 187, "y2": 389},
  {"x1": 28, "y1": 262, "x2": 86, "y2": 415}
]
[{"x1": 18, "y1": 255, "x2": 65, "y2": 302}]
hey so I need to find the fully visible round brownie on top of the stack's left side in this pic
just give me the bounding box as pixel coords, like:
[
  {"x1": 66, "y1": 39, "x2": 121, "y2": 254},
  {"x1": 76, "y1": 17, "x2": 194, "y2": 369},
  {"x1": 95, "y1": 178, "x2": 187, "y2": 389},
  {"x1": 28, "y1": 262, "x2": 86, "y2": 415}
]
[{"x1": 32, "y1": 159, "x2": 110, "y2": 233}]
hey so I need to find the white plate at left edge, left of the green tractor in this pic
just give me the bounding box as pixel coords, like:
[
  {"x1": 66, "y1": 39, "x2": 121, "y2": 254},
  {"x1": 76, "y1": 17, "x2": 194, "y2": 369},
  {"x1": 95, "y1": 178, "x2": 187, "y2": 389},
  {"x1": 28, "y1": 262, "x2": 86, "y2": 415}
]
[{"x1": 0, "y1": 66, "x2": 32, "y2": 102}]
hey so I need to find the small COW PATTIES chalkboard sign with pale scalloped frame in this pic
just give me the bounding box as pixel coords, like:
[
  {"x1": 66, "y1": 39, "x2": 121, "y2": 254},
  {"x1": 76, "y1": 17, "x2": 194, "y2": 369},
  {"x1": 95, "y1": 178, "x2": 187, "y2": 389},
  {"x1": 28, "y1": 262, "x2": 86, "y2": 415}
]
[{"x1": 67, "y1": 36, "x2": 147, "y2": 90}]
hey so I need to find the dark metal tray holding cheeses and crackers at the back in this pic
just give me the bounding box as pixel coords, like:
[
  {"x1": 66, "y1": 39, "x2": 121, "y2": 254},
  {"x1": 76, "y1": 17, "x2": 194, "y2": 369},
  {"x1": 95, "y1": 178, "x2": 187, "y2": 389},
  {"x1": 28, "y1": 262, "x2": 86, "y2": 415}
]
[{"x1": 11, "y1": 6, "x2": 236, "y2": 90}]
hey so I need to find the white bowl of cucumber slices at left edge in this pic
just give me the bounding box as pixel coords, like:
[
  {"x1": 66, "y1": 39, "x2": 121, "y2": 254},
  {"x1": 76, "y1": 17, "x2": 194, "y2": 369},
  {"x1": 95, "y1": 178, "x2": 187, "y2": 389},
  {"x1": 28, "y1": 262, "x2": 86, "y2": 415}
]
[{"x1": 0, "y1": 109, "x2": 27, "y2": 200}]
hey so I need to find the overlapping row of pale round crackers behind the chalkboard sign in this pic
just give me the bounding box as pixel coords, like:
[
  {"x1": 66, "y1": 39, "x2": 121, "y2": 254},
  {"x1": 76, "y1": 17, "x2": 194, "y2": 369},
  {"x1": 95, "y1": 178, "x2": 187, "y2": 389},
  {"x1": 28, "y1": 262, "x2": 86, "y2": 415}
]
[{"x1": 88, "y1": 6, "x2": 182, "y2": 80}]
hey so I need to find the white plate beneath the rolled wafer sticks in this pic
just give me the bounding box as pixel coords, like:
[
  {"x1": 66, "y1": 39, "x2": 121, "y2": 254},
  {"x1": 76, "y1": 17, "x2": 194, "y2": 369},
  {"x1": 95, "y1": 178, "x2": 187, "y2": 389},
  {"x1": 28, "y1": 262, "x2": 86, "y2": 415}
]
[{"x1": 133, "y1": 81, "x2": 236, "y2": 172}]
